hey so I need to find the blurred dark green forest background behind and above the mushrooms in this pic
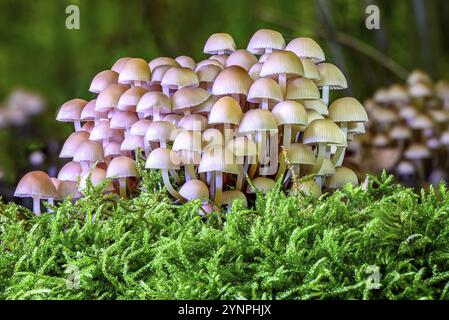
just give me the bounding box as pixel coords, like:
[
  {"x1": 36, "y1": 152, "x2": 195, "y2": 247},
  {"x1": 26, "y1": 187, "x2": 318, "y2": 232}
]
[{"x1": 0, "y1": 0, "x2": 449, "y2": 200}]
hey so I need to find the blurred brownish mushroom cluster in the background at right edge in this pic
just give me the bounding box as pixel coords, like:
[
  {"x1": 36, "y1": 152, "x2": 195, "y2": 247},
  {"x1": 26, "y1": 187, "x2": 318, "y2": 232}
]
[{"x1": 349, "y1": 70, "x2": 449, "y2": 186}]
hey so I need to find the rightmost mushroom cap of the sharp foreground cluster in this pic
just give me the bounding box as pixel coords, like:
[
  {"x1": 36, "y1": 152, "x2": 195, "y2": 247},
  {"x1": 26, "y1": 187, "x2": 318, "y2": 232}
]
[{"x1": 329, "y1": 97, "x2": 368, "y2": 123}]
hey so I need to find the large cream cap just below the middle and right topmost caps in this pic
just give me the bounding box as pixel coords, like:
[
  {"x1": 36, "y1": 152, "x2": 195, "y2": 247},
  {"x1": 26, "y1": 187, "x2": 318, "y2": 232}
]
[{"x1": 260, "y1": 51, "x2": 304, "y2": 78}]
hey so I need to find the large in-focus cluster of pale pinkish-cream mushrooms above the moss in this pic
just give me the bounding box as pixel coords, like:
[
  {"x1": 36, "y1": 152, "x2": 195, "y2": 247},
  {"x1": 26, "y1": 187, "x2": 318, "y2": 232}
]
[{"x1": 16, "y1": 29, "x2": 368, "y2": 215}]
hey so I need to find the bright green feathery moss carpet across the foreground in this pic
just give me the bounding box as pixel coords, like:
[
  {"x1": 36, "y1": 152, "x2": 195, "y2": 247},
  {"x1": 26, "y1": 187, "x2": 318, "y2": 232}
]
[{"x1": 0, "y1": 172, "x2": 449, "y2": 299}]
